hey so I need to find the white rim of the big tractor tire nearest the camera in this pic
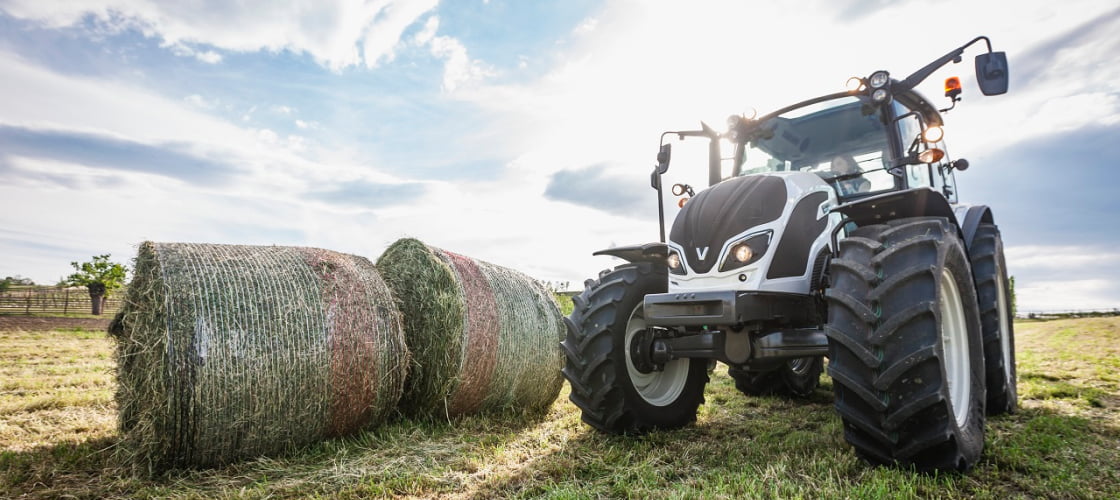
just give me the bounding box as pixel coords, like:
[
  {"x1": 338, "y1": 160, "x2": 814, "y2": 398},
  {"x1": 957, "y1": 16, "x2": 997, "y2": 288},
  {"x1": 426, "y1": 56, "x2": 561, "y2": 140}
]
[{"x1": 940, "y1": 269, "x2": 972, "y2": 427}]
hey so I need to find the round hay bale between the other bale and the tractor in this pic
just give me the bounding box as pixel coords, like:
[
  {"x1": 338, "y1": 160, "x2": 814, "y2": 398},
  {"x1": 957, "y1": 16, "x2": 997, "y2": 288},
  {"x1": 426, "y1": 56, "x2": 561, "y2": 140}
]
[{"x1": 377, "y1": 239, "x2": 563, "y2": 417}]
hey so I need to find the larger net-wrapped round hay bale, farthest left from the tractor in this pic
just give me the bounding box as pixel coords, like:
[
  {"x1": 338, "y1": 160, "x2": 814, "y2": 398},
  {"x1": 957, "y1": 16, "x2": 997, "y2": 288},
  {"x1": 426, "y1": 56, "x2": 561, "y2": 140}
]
[{"x1": 111, "y1": 242, "x2": 409, "y2": 472}]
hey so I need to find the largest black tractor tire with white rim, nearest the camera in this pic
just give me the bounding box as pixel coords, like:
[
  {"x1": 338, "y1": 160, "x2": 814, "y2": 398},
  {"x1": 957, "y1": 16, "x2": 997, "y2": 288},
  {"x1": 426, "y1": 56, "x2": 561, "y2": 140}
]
[{"x1": 825, "y1": 217, "x2": 986, "y2": 471}]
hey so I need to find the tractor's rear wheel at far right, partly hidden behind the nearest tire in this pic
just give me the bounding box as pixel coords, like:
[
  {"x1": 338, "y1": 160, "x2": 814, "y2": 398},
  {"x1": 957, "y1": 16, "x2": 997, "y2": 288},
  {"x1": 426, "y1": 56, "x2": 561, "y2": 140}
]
[{"x1": 969, "y1": 224, "x2": 1019, "y2": 415}]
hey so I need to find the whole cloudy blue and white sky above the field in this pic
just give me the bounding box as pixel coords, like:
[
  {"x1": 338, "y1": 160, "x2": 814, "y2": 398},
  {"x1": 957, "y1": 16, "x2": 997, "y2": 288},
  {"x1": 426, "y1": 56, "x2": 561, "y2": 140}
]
[{"x1": 0, "y1": 0, "x2": 1120, "y2": 311}]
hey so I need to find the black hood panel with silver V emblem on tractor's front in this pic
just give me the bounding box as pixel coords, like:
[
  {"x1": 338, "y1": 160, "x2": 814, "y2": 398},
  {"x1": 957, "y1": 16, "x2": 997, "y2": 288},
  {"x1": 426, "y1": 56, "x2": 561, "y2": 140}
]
[{"x1": 669, "y1": 175, "x2": 786, "y2": 272}]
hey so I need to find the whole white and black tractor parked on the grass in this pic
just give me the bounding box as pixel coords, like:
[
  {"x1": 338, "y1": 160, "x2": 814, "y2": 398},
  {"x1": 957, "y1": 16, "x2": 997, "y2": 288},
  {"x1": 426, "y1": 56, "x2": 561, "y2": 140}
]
[{"x1": 562, "y1": 37, "x2": 1016, "y2": 471}]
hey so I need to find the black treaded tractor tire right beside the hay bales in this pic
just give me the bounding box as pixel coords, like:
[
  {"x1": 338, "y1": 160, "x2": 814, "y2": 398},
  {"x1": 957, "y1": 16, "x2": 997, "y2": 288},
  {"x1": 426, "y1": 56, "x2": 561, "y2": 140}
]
[{"x1": 561, "y1": 262, "x2": 708, "y2": 434}]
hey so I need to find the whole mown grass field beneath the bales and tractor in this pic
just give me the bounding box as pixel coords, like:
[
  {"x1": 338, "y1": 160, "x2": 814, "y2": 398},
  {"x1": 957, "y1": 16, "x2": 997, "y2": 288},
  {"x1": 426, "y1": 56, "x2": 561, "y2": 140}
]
[{"x1": 0, "y1": 317, "x2": 1120, "y2": 499}]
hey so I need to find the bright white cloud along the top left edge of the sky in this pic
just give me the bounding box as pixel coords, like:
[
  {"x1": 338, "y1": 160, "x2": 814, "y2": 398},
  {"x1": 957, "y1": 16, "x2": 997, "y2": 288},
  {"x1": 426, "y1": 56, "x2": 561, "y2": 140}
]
[{"x1": 3, "y1": 0, "x2": 438, "y2": 70}]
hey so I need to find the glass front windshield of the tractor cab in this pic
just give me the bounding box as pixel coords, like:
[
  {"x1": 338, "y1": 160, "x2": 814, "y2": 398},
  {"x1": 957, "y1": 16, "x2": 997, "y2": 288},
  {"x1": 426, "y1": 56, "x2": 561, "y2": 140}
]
[{"x1": 735, "y1": 96, "x2": 895, "y2": 196}]
